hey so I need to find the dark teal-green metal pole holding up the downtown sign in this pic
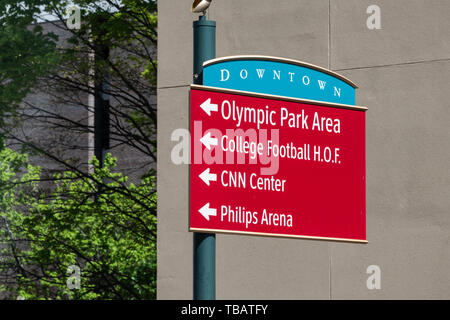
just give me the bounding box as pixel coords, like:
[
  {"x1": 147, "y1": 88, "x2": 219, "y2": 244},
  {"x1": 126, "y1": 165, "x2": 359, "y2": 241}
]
[{"x1": 193, "y1": 16, "x2": 216, "y2": 300}]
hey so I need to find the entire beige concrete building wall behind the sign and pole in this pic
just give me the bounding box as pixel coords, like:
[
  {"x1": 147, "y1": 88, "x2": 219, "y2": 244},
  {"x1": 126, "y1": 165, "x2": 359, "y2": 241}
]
[{"x1": 158, "y1": 0, "x2": 450, "y2": 299}]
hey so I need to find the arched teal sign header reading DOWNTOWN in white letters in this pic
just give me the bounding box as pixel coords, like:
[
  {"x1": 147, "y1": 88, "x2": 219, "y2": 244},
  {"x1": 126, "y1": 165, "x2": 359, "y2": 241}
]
[{"x1": 203, "y1": 56, "x2": 357, "y2": 105}]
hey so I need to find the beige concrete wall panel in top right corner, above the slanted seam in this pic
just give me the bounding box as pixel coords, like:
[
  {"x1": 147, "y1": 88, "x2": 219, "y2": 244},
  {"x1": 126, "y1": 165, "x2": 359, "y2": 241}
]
[{"x1": 330, "y1": 0, "x2": 450, "y2": 70}]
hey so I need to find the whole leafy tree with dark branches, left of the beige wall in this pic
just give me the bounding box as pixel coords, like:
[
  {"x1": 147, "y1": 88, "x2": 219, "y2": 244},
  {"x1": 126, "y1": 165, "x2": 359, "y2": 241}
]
[{"x1": 0, "y1": 0, "x2": 157, "y2": 299}]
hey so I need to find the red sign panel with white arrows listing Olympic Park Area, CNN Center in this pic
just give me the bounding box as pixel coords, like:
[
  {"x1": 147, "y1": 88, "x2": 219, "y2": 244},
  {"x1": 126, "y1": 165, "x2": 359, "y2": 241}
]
[{"x1": 190, "y1": 86, "x2": 366, "y2": 242}]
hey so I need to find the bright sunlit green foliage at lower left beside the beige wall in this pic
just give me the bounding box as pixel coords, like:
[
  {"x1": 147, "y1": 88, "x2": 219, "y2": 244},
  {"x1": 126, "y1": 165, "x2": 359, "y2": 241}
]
[{"x1": 0, "y1": 148, "x2": 156, "y2": 299}]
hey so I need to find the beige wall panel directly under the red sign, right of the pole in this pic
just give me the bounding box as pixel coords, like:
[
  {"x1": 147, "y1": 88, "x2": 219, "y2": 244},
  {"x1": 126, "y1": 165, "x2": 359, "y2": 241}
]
[{"x1": 216, "y1": 235, "x2": 330, "y2": 300}]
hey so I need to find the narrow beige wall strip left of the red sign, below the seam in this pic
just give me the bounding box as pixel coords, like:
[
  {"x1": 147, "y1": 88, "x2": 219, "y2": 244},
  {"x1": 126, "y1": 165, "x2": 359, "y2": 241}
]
[{"x1": 157, "y1": 87, "x2": 193, "y2": 299}]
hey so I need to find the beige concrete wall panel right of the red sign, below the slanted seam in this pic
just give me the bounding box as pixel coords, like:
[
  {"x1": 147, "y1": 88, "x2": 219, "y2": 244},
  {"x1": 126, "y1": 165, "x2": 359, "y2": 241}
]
[{"x1": 331, "y1": 61, "x2": 450, "y2": 299}]
